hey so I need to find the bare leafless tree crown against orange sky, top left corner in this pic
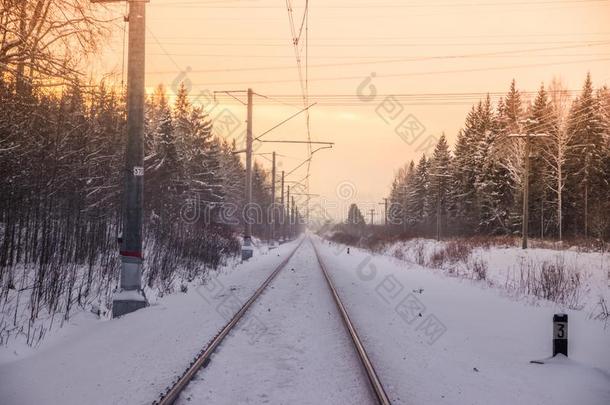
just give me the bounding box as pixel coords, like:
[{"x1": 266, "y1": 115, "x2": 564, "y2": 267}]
[{"x1": 0, "y1": 0, "x2": 111, "y2": 83}]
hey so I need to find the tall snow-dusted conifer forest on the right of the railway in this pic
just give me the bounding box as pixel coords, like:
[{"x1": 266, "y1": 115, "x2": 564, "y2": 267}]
[{"x1": 388, "y1": 75, "x2": 610, "y2": 241}]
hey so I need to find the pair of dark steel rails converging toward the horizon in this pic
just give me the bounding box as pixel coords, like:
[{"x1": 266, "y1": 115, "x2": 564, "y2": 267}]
[{"x1": 153, "y1": 238, "x2": 390, "y2": 405}]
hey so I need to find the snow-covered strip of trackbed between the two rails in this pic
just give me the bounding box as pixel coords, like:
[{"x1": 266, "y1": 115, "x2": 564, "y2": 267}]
[{"x1": 178, "y1": 241, "x2": 374, "y2": 405}]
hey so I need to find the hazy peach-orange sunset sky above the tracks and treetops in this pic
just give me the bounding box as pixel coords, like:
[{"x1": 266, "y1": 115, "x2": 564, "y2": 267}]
[{"x1": 91, "y1": 0, "x2": 610, "y2": 220}]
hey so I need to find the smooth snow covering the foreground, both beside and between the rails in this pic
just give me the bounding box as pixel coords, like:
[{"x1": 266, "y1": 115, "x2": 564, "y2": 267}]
[{"x1": 0, "y1": 237, "x2": 610, "y2": 405}]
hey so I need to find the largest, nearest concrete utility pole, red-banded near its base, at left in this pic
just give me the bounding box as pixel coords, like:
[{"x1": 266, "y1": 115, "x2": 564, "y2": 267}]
[{"x1": 92, "y1": 0, "x2": 148, "y2": 318}]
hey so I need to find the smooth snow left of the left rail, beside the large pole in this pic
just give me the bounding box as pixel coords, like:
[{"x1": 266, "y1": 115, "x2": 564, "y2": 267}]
[{"x1": 0, "y1": 238, "x2": 296, "y2": 405}]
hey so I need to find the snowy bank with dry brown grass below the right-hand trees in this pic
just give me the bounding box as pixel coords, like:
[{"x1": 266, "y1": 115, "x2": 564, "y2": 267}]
[{"x1": 380, "y1": 238, "x2": 610, "y2": 318}]
